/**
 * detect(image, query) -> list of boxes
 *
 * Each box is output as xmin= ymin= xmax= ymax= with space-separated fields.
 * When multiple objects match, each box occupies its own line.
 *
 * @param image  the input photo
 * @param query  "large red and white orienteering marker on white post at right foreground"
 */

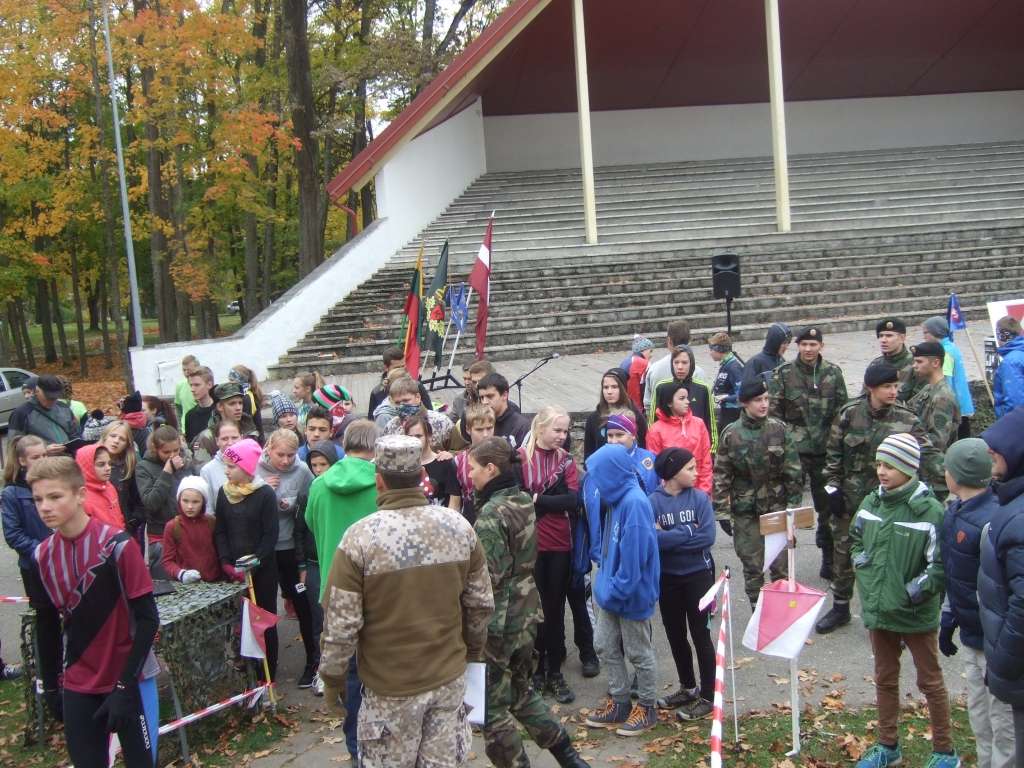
xmin=743 ymin=579 xmax=825 ymax=658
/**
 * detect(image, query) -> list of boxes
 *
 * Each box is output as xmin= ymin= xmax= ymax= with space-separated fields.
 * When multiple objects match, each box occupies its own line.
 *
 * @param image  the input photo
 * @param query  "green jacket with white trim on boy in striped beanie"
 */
xmin=850 ymin=477 xmax=945 ymax=633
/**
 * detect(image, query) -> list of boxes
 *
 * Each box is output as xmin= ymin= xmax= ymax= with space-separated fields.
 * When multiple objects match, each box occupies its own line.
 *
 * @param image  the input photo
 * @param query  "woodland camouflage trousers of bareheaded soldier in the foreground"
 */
xmin=483 ymin=642 xmax=563 ymax=768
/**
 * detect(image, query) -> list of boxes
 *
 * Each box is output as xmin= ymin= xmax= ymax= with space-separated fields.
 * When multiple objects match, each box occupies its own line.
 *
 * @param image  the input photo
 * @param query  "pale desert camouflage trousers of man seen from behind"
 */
xmin=358 ymin=675 xmax=473 ymax=768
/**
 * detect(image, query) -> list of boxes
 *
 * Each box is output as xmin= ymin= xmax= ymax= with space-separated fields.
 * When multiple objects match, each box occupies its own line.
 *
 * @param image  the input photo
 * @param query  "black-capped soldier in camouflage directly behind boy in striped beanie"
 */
xmin=817 ymin=360 xmax=943 ymax=634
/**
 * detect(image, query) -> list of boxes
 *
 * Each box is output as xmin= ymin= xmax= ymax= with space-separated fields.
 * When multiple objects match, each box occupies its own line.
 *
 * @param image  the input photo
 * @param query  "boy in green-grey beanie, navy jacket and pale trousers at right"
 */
xmin=939 ymin=437 xmax=1014 ymax=768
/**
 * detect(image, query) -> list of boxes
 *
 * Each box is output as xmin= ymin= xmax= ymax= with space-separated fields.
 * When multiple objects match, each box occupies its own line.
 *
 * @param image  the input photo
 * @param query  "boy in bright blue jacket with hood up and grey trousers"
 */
xmin=586 ymin=444 xmax=660 ymax=736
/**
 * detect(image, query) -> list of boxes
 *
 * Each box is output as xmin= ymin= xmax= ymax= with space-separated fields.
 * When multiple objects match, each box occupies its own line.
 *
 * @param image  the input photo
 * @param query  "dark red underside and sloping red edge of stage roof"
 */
xmin=330 ymin=0 xmax=1024 ymax=195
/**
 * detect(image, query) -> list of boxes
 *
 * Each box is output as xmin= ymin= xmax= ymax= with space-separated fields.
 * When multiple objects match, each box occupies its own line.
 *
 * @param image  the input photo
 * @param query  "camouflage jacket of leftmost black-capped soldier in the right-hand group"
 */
xmin=712 ymin=411 xmax=804 ymax=519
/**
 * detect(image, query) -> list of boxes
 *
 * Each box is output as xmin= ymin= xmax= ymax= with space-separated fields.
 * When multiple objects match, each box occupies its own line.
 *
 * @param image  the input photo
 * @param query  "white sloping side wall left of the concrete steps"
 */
xmin=131 ymin=101 xmax=486 ymax=394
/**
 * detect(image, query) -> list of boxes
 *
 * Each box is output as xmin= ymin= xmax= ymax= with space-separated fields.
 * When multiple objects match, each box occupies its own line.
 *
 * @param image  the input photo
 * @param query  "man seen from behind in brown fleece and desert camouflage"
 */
xmin=319 ymin=435 xmax=495 ymax=768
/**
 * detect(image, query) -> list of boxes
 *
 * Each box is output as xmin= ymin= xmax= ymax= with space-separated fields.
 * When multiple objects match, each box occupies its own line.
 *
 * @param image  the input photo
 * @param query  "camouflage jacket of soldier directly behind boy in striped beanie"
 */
xmin=825 ymin=394 xmax=942 ymax=514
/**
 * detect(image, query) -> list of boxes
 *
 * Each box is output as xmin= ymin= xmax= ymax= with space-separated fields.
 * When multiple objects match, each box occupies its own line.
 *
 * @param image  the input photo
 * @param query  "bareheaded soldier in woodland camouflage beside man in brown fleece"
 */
xmin=469 ymin=437 xmax=588 ymax=768
